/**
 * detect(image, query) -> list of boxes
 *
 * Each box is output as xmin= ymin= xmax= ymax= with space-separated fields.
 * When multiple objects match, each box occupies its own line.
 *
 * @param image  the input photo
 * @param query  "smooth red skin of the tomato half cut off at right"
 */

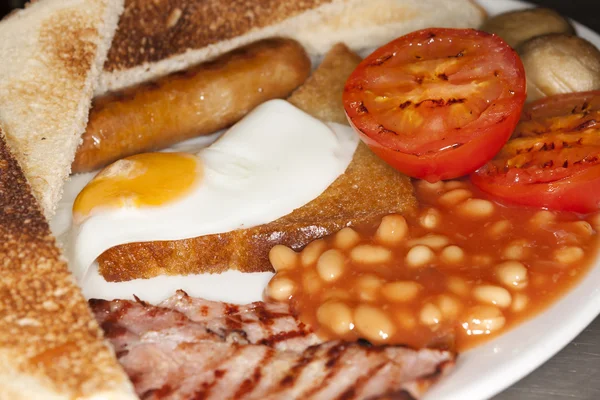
xmin=471 ymin=165 xmax=600 ymax=214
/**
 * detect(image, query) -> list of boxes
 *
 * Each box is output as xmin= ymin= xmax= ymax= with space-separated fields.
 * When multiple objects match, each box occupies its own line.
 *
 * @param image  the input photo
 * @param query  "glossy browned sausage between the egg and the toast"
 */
xmin=72 ymin=38 xmax=310 ymax=173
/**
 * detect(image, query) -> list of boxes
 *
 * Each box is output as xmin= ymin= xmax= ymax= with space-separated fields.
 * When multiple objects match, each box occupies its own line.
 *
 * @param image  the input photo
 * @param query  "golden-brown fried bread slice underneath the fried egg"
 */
xmin=98 ymin=45 xmax=416 ymax=281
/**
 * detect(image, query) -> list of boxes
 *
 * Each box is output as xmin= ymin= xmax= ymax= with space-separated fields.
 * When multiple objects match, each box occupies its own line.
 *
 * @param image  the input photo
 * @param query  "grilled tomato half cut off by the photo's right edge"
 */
xmin=471 ymin=91 xmax=600 ymax=213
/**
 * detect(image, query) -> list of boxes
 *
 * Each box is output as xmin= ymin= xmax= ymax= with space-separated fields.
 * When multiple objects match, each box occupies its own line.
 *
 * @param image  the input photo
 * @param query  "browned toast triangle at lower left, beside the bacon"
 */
xmin=0 ymin=130 xmax=136 ymax=400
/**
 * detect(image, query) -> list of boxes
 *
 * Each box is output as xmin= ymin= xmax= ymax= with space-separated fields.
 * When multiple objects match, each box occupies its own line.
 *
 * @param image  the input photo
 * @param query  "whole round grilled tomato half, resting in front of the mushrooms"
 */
xmin=343 ymin=28 xmax=526 ymax=182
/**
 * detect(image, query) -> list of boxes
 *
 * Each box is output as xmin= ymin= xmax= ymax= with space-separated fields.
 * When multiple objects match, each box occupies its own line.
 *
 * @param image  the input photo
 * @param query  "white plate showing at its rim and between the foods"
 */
xmin=51 ymin=0 xmax=600 ymax=400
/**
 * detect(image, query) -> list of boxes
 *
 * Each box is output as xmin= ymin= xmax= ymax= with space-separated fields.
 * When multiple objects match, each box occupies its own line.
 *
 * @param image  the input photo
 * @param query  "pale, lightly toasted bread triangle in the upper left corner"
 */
xmin=0 ymin=0 xmax=123 ymax=218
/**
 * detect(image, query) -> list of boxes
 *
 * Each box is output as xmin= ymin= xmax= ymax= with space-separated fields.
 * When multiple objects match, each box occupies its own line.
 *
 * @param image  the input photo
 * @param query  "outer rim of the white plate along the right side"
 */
xmin=425 ymin=0 xmax=600 ymax=400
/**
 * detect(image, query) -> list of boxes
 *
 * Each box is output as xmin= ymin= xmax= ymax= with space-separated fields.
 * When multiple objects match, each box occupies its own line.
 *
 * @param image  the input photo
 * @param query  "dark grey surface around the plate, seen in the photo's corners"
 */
xmin=0 ymin=0 xmax=600 ymax=400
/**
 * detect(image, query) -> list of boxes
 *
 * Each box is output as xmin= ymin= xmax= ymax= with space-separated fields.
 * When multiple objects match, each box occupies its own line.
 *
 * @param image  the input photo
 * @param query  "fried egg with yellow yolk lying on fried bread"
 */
xmin=65 ymin=100 xmax=359 ymax=281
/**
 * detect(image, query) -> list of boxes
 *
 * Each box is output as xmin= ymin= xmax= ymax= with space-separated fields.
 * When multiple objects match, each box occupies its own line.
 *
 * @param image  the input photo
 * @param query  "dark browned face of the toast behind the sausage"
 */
xmin=104 ymin=0 xmax=332 ymax=72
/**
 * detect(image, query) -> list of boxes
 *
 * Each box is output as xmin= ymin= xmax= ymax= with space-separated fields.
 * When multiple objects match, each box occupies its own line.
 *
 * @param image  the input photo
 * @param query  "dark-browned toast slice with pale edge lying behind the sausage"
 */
xmin=97 ymin=0 xmax=485 ymax=94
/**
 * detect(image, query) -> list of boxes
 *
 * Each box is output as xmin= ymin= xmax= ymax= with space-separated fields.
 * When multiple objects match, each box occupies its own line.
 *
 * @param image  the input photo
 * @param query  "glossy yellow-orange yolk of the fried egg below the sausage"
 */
xmin=73 ymin=153 xmax=202 ymax=223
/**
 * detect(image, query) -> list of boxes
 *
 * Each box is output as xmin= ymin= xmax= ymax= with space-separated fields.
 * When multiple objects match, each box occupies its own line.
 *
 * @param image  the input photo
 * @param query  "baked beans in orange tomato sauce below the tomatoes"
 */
xmin=266 ymin=181 xmax=600 ymax=351
